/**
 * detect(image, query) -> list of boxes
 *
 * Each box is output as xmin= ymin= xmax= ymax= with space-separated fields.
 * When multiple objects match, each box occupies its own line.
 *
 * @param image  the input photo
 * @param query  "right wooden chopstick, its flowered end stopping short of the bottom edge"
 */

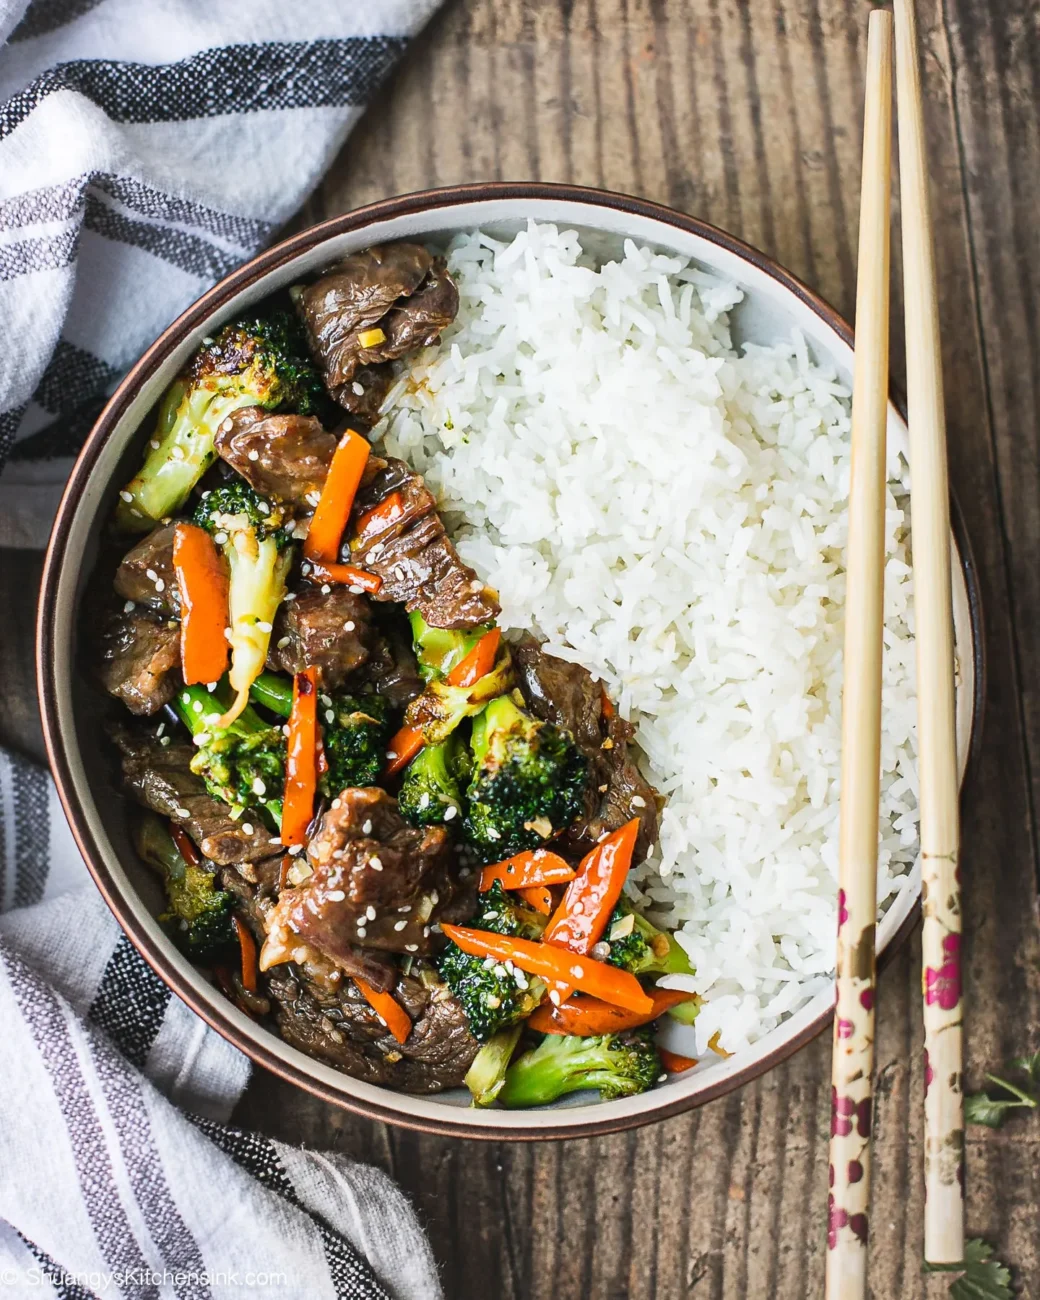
xmin=896 ymin=0 xmax=965 ymax=1264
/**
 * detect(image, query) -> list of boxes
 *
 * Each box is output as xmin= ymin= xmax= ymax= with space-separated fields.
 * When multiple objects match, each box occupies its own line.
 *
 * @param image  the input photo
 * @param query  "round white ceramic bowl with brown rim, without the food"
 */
xmin=38 ymin=183 xmax=982 ymax=1139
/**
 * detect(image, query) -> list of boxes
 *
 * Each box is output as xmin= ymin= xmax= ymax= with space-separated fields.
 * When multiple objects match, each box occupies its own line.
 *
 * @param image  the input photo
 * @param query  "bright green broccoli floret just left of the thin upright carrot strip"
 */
xmin=170 ymin=683 xmax=286 ymax=822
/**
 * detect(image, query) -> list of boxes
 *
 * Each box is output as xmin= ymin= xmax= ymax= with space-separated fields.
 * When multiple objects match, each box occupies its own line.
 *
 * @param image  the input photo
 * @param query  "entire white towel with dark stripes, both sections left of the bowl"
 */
xmin=0 ymin=0 xmax=441 ymax=1300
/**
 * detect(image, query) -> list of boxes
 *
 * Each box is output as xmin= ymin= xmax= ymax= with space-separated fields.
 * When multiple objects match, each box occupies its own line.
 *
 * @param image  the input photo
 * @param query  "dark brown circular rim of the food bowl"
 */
xmin=36 ymin=181 xmax=985 ymax=1141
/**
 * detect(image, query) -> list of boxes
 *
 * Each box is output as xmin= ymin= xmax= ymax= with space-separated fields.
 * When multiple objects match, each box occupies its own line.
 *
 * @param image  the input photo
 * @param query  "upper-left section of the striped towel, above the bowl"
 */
xmin=0 ymin=0 xmax=439 ymax=546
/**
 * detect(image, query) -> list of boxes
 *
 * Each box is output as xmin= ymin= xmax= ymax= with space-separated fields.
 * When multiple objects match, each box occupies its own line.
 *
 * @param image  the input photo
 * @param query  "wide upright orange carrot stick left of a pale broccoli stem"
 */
xmin=173 ymin=524 xmax=228 ymax=686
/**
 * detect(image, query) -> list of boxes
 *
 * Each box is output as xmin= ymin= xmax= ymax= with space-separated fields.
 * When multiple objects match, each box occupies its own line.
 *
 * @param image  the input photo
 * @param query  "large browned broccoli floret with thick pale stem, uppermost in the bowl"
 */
xmin=116 ymin=312 xmax=328 ymax=532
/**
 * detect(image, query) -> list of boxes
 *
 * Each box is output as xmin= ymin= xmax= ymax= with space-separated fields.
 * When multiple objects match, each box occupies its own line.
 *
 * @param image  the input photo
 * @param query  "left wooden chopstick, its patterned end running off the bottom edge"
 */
xmin=827 ymin=9 xmax=892 ymax=1300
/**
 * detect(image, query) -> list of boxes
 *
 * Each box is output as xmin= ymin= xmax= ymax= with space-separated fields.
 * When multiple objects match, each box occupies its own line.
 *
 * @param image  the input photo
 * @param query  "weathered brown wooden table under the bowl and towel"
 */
xmin=0 ymin=0 xmax=1040 ymax=1300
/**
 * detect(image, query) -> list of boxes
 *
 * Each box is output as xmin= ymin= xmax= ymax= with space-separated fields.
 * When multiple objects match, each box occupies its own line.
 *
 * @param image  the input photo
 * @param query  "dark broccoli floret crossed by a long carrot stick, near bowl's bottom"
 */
xmin=437 ymin=881 xmax=545 ymax=1043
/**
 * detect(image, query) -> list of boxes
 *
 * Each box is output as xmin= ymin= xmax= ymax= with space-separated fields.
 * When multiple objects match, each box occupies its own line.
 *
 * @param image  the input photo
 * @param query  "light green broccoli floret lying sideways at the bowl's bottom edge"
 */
xmin=498 ymin=1027 xmax=660 ymax=1108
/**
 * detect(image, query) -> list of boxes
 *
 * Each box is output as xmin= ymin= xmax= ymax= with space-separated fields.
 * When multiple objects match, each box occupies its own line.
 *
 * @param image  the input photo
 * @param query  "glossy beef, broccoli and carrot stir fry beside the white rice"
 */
xmin=90 ymin=243 xmax=698 ymax=1106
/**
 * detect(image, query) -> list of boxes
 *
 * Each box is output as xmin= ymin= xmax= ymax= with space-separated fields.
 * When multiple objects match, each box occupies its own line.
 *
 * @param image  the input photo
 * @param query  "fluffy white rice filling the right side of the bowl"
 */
xmin=385 ymin=224 xmax=918 ymax=1050
